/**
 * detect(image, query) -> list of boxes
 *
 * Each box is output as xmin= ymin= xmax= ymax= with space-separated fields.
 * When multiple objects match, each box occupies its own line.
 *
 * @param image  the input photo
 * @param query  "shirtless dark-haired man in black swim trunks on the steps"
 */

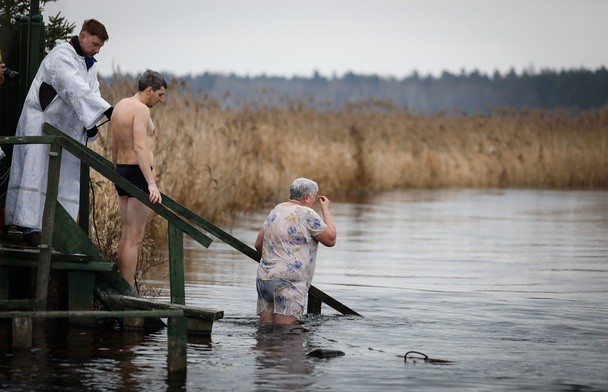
xmin=111 ymin=70 xmax=167 ymax=287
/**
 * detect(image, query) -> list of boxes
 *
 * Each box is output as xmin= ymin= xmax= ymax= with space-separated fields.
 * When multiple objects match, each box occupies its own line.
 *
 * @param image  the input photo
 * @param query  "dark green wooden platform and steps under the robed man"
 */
xmin=0 ymin=227 xmax=224 ymax=335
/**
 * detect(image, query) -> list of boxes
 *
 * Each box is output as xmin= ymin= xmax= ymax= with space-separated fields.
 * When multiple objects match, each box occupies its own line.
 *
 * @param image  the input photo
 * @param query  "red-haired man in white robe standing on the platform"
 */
xmin=5 ymin=19 xmax=113 ymax=246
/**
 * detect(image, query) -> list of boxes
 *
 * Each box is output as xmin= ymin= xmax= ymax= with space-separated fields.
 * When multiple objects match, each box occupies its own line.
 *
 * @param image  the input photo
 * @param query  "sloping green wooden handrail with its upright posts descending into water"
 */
xmin=0 ymin=124 xmax=360 ymax=316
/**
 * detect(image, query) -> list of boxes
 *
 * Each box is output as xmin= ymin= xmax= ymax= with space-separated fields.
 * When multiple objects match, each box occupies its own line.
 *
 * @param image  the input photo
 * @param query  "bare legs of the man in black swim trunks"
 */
xmin=118 ymin=196 xmax=150 ymax=287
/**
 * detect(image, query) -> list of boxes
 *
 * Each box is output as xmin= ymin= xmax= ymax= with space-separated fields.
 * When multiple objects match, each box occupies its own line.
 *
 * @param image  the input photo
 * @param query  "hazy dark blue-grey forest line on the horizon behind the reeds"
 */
xmin=163 ymin=67 xmax=608 ymax=114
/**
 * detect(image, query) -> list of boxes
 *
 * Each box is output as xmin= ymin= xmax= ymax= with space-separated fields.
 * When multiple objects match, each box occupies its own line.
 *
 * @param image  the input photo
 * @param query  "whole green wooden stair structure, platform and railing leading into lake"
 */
xmin=0 ymin=124 xmax=359 ymax=373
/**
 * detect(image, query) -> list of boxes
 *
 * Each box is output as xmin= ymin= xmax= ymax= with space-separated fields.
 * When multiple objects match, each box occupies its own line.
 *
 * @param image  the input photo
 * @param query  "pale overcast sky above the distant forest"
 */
xmin=44 ymin=0 xmax=608 ymax=78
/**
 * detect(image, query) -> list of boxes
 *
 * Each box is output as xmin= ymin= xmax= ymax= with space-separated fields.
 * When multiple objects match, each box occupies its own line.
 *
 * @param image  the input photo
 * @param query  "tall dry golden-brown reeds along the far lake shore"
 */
xmin=92 ymin=80 xmax=608 ymax=276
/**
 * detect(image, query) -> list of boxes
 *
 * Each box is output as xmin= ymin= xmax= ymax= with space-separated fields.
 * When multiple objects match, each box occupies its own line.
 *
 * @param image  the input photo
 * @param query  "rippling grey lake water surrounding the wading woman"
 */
xmin=0 ymin=189 xmax=608 ymax=391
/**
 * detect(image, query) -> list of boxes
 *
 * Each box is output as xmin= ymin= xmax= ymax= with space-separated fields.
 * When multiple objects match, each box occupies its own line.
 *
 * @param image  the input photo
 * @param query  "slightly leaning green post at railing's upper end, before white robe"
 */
xmin=35 ymin=142 xmax=61 ymax=310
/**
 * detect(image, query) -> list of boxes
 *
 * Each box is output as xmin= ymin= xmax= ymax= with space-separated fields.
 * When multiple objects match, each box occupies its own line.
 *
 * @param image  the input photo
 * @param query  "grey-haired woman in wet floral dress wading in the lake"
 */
xmin=255 ymin=178 xmax=336 ymax=324
